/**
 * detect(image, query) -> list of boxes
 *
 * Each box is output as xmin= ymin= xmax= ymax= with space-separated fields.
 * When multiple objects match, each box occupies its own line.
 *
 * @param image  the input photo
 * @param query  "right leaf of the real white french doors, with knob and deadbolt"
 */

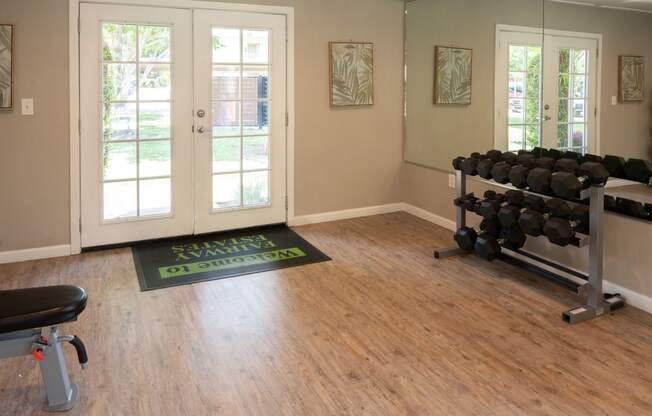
xmin=194 ymin=10 xmax=286 ymax=233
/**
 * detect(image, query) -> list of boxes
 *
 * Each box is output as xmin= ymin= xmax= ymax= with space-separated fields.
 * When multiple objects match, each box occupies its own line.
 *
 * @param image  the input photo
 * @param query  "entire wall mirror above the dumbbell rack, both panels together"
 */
xmin=404 ymin=0 xmax=652 ymax=171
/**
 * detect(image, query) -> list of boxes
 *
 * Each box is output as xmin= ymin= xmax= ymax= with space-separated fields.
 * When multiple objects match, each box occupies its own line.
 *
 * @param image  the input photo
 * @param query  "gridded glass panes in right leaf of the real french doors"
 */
xmin=211 ymin=28 xmax=272 ymax=211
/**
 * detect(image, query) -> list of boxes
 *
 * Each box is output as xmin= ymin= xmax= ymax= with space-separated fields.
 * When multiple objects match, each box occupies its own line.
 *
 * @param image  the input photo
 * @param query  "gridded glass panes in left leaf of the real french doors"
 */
xmin=101 ymin=22 xmax=173 ymax=221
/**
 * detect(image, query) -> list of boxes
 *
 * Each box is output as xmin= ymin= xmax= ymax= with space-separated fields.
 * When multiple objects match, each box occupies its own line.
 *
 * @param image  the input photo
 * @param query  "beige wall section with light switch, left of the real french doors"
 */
xmin=0 ymin=0 xmax=70 ymax=252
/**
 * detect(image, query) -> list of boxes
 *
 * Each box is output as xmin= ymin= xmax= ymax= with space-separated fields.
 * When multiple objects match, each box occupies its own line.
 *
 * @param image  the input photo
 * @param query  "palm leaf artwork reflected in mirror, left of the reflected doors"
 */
xmin=434 ymin=46 xmax=472 ymax=105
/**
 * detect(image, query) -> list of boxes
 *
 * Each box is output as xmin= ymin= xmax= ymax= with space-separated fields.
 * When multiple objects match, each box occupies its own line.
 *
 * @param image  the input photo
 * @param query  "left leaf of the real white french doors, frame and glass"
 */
xmin=80 ymin=4 xmax=193 ymax=247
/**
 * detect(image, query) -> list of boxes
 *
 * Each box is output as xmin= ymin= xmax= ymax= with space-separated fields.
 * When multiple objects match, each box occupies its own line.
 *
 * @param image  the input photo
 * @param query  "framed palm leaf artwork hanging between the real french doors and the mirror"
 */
xmin=330 ymin=42 xmax=374 ymax=106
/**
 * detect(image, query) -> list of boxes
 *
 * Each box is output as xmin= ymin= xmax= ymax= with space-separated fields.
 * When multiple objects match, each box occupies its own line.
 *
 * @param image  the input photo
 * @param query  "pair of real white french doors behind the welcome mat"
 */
xmin=80 ymin=3 xmax=286 ymax=247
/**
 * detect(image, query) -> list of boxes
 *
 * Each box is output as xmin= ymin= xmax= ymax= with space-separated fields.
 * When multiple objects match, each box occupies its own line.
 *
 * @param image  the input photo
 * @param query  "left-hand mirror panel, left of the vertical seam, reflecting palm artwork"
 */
xmin=404 ymin=0 xmax=544 ymax=171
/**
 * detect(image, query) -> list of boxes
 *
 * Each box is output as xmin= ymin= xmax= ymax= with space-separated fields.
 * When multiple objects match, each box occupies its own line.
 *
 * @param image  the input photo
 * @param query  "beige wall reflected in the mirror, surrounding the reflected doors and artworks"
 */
xmin=405 ymin=0 xmax=652 ymax=170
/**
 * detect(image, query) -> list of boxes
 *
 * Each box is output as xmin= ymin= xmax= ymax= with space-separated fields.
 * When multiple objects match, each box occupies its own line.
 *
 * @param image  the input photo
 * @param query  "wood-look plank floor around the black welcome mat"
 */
xmin=0 ymin=213 xmax=652 ymax=416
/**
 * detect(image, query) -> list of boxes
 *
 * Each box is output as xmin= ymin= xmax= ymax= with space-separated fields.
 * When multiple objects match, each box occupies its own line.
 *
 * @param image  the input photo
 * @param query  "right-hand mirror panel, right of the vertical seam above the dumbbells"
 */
xmin=542 ymin=0 xmax=652 ymax=159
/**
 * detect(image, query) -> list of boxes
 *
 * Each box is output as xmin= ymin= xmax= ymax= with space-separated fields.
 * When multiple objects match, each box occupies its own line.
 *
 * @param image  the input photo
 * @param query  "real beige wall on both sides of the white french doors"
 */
xmin=0 ymin=0 xmax=403 ymax=251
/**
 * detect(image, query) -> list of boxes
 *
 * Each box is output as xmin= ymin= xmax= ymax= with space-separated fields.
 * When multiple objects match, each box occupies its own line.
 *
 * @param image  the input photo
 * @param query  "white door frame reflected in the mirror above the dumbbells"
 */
xmin=494 ymin=24 xmax=602 ymax=155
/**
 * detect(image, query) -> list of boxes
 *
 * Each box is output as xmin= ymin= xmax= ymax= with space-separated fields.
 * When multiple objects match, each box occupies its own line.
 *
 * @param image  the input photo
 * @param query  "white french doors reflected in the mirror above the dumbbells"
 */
xmin=494 ymin=26 xmax=598 ymax=153
